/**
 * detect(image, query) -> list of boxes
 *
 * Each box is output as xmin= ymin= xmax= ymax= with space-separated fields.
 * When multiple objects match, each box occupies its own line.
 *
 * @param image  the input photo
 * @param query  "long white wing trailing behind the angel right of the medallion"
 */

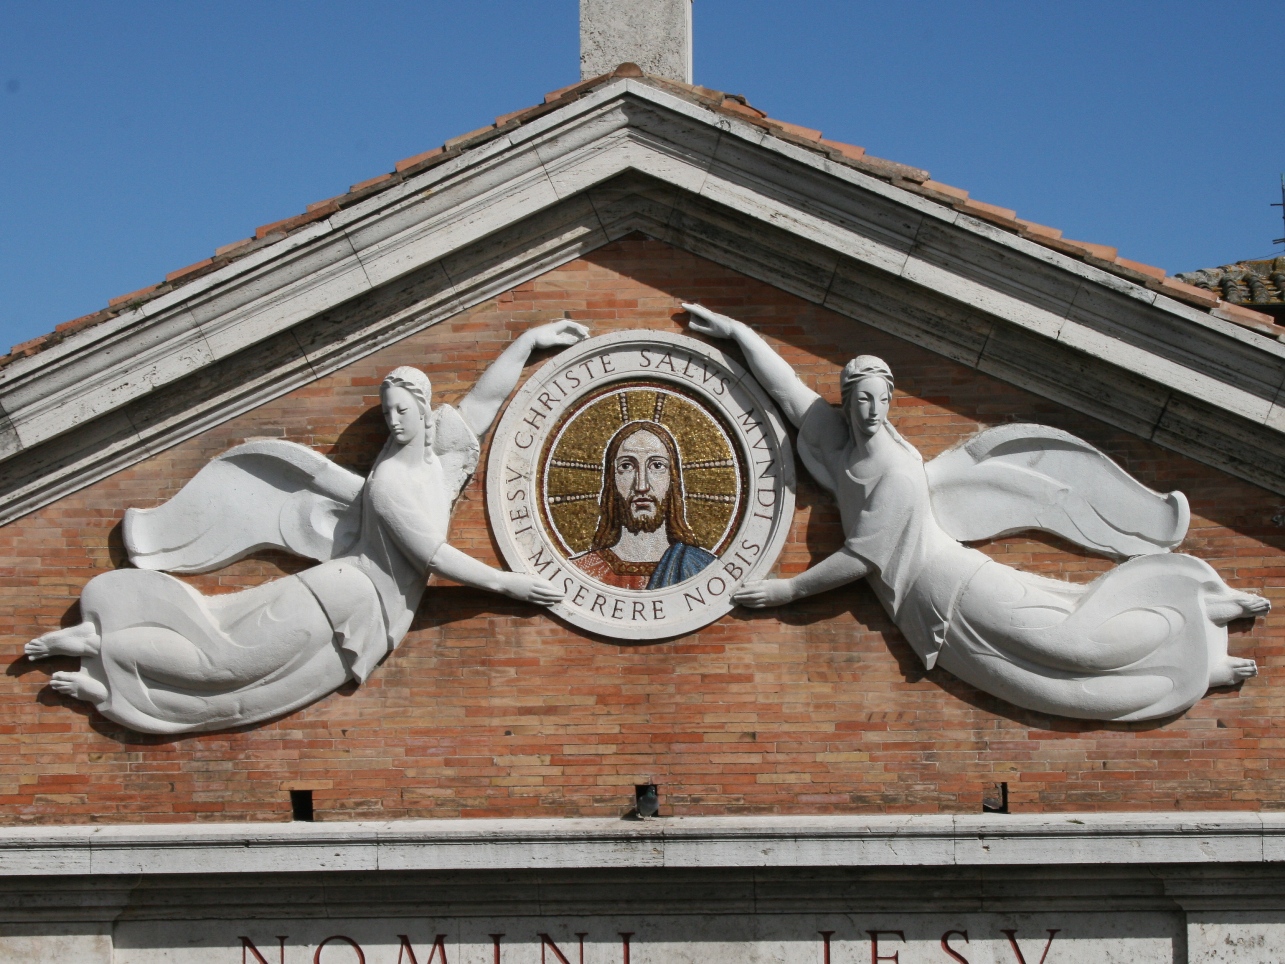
xmin=926 ymin=424 xmax=1191 ymax=558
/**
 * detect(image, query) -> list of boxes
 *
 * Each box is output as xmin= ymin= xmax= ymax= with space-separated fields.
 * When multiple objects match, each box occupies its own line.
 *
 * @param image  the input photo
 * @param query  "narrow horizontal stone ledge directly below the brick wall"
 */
xmin=0 ymin=811 xmax=1285 ymax=877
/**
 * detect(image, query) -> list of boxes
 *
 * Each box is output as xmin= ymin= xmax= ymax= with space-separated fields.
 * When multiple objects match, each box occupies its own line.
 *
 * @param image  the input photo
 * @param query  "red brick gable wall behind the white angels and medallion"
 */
xmin=0 ymin=240 xmax=1285 ymax=824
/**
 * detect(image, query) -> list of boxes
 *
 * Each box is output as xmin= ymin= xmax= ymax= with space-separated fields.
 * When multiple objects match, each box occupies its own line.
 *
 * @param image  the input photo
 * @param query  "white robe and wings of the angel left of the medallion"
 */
xmin=72 ymin=405 xmax=479 ymax=734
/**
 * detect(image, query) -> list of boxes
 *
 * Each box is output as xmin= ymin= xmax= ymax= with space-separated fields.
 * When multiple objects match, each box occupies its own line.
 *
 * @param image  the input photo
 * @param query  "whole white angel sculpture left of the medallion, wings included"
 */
xmin=26 ymin=321 xmax=589 ymax=734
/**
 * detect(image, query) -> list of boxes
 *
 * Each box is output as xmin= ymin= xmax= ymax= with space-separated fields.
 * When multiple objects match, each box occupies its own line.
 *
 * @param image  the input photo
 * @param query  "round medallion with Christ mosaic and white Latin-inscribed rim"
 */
xmin=487 ymin=332 xmax=794 ymax=640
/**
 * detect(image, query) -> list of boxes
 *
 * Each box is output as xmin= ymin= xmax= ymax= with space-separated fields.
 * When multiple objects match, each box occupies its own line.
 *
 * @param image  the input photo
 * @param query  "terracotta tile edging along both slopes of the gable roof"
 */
xmin=0 ymin=63 xmax=1285 ymax=368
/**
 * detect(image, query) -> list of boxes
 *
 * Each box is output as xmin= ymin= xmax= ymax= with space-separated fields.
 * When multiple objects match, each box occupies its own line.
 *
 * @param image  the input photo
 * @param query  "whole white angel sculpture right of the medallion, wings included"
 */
xmin=684 ymin=305 xmax=1270 ymax=720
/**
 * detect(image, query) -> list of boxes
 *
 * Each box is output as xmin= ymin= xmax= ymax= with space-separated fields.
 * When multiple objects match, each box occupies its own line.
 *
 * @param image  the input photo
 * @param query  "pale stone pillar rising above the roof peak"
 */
xmin=580 ymin=0 xmax=693 ymax=84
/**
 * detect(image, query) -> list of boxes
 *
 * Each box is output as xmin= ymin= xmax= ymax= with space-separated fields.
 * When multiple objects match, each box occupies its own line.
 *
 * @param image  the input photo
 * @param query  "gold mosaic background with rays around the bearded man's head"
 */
xmin=541 ymin=382 xmax=745 ymax=554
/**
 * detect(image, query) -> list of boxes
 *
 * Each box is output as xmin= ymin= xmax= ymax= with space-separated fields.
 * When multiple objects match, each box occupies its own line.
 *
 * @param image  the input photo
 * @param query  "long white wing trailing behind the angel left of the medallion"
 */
xmin=125 ymin=440 xmax=362 ymax=572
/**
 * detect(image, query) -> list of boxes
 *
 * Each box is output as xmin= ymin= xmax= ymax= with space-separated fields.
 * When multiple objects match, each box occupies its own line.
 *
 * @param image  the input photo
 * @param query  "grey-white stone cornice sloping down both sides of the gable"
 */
xmin=0 ymin=78 xmax=1285 ymax=523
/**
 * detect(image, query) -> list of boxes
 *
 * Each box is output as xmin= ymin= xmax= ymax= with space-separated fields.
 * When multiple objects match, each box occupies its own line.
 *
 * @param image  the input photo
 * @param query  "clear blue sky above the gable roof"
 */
xmin=0 ymin=0 xmax=1285 ymax=351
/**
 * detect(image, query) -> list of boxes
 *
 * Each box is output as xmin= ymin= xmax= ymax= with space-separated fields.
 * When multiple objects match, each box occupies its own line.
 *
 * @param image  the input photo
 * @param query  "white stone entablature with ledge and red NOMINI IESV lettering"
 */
xmin=0 ymin=812 xmax=1285 ymax=964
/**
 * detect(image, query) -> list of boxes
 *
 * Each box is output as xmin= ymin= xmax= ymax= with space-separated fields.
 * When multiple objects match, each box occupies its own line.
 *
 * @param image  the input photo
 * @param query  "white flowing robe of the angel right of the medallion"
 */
xmin=798 ymin=405 xmax=1226 ymax=720
